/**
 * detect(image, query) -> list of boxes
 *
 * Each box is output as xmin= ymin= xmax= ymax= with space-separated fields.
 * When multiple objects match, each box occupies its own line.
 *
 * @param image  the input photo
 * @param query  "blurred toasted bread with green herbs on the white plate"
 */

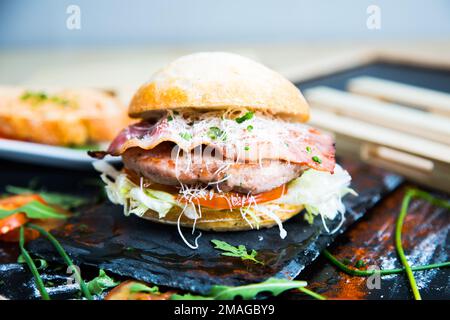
xmin=0 ymin=86 xmax=130 ymax=146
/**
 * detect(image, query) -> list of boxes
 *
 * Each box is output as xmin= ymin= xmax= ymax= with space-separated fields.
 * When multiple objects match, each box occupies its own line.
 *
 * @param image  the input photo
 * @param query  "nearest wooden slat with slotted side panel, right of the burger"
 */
xmin=310 ymin=104 xmax=450 ymax=192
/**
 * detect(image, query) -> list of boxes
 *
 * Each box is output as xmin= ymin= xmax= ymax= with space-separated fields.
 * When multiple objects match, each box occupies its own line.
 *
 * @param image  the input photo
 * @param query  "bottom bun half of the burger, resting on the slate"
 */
xmin=142 ymin=204 xmax=303 ymax=231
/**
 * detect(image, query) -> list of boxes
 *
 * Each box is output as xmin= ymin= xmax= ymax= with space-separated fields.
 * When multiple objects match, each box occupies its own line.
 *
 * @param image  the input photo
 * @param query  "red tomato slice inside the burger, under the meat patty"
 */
xmin=178 ymin=184 xmax=286 ymax=210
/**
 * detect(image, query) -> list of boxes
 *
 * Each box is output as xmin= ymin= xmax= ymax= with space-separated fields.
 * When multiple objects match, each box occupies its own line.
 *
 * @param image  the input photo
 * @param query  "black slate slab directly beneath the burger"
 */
xmin=29 ymin=162 xmax=402 ymax=293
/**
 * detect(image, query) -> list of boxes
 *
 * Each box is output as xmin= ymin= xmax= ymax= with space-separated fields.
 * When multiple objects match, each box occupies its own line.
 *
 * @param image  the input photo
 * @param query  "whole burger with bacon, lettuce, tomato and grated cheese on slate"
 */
xmin=90 ymin=52 xmax=352 ymax=248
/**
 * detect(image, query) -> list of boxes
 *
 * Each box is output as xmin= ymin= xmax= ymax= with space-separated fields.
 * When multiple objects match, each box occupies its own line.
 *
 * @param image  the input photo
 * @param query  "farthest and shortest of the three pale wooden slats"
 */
xmin=348 ymin=77 xmax=450 ymax=117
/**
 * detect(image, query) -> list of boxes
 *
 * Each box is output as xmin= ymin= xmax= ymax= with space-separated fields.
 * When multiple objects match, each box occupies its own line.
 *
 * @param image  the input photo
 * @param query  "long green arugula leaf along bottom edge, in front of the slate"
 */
xmin=170 ymin=278 xmax=307 ymax=300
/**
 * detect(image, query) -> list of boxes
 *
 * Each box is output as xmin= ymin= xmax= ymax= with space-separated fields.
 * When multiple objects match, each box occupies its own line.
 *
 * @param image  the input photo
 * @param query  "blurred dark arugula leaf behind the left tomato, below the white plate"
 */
xmin=5 ymin=186 xmax=89 ymax=210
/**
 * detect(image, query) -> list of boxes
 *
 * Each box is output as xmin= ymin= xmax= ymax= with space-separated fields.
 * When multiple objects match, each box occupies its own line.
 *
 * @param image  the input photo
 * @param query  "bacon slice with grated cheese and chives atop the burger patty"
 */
xmin=90 ymin=116 xmax=335 ymax=172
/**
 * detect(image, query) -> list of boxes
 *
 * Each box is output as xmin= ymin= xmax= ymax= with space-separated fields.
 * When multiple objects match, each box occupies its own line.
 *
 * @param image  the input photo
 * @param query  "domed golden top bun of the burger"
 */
xmin=128 ymin=52 xmax=309 ymax=122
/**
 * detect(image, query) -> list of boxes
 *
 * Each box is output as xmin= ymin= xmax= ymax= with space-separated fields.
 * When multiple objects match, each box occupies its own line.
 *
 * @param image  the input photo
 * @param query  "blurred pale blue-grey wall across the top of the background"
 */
xmin=0 ymin=0 xmax=450 ymax=48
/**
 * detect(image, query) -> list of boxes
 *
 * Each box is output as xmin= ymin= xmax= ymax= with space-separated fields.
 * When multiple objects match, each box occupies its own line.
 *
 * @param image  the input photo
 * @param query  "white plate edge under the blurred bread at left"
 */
xmin=0 ymin=139 xmax=120 ymax=169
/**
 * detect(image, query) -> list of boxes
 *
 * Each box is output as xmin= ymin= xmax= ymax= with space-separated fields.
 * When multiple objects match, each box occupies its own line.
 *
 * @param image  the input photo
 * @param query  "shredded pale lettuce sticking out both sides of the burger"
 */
xmin=94 ymin=161 xmax=356 ymax=234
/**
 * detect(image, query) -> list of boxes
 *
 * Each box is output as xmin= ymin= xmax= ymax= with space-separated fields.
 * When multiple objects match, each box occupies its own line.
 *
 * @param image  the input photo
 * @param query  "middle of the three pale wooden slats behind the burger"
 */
xmin=305 ymin=87 xmax=450 ymax=145
